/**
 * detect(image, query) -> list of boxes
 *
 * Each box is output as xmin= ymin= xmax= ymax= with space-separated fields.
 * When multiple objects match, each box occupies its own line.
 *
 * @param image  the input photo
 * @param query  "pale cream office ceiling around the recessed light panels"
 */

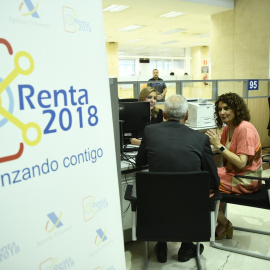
xmin=102 ymin=0 xmax=234 ymax=58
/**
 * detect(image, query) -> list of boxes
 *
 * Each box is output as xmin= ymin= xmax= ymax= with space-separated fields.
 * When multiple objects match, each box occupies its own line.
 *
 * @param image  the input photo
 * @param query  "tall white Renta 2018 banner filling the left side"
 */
xmin=0 ymin=0 xmax=125 ymax=270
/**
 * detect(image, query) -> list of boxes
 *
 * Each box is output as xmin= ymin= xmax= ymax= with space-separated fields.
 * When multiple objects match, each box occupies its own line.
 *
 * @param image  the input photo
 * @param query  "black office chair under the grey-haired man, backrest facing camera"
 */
xmin=125 ymin=171 xmax=221 ymax=269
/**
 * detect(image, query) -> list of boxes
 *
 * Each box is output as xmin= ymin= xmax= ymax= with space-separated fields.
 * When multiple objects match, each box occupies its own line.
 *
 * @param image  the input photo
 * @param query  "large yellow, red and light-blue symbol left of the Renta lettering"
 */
xmin=0 ymin=39 xmax=42 ymax=163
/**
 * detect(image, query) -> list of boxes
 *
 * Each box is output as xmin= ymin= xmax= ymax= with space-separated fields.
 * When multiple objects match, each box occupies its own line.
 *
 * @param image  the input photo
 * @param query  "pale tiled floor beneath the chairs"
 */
xmin=125 ymin=165 xmax=270 ymax=270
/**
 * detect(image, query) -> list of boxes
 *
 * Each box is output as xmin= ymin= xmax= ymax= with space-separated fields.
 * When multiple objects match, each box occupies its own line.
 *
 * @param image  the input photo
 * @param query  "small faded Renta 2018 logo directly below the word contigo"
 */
xmin=82 ymin=196 xmax=109 ymax=222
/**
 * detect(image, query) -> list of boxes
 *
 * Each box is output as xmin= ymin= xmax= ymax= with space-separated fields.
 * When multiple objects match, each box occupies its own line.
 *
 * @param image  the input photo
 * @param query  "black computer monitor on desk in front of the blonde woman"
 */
xmin=118 ymin=102 xmax=150 ymax=142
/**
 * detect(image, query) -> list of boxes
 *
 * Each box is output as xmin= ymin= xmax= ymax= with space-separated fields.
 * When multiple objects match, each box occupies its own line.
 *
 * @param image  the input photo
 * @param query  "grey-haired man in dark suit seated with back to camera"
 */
xmin=136 ymin=95 xmax=220 ymax=263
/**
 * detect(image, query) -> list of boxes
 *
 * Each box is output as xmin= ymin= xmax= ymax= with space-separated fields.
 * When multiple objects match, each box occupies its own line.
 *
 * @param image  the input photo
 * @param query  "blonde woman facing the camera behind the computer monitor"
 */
xmin=130 ymin=86 xmax=163 ymax=145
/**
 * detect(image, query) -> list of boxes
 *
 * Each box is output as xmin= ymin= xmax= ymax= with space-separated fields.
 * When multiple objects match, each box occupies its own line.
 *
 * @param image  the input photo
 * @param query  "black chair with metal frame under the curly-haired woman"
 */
xmin=211 ymin=175 xmax=270 ymax=260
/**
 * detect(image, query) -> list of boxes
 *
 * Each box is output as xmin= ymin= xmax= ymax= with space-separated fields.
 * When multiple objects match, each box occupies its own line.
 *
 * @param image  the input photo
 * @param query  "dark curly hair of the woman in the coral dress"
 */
xmin=215 ymin=93 xmax=250 ymax=128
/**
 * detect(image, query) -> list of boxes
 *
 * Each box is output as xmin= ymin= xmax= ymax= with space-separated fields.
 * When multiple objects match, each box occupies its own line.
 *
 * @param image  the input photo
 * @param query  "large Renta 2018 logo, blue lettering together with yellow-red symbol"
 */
xmin=0 ymin=38 xmax=99 ymax=167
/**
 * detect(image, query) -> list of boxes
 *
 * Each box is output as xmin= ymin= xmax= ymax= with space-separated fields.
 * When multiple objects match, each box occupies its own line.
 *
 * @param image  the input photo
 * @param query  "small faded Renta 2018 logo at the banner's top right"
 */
xmin=63 ymin=7 xmax=92 ymax=33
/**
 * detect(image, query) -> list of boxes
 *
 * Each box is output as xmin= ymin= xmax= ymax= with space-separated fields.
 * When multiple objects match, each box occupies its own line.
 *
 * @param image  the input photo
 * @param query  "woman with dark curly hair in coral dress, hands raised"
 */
xmin=206 ymin=93 xmax=262 ymax=240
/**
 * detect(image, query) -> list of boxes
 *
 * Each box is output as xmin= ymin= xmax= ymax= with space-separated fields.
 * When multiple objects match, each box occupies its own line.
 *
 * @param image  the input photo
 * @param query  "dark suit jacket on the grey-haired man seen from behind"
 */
xmin=137 ymin=121 xmax=219 ymax=189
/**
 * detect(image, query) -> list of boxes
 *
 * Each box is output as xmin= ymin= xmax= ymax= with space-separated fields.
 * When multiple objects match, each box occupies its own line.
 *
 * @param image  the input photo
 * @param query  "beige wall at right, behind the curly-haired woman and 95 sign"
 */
xmin=211 ymin=0 xmax=270 ymax=146
